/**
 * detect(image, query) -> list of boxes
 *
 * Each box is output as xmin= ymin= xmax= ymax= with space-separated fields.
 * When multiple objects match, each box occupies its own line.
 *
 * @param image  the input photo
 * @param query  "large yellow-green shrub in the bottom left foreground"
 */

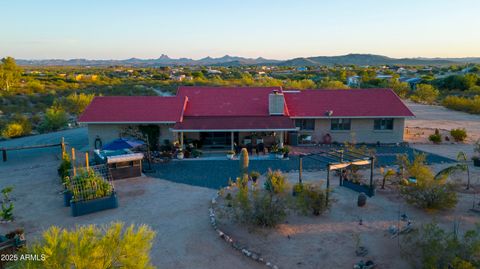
xmin=15 ymin=222 xmax=155 ymax=269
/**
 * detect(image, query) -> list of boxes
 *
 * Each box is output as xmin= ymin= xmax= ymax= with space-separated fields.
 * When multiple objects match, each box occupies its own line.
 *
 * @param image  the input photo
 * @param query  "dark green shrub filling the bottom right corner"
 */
xmin=402 ymin=223 xmax=480 ymax=269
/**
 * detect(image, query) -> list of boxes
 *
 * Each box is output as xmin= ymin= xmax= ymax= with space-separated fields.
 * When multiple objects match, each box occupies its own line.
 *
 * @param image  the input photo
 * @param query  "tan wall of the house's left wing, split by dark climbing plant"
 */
xmin=88 ymin=124 xmax=173 ymax=150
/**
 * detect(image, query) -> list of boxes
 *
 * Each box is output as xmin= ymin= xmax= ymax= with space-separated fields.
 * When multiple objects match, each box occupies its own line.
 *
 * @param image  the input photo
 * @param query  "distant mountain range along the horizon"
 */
xmin=17 ymin=54 xmax=480 ymax=67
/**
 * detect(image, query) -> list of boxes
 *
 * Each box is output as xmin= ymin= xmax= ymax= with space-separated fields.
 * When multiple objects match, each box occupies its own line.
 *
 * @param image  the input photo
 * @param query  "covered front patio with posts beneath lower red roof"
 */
xmin=172 ymin=116 xmax=297 ymax=153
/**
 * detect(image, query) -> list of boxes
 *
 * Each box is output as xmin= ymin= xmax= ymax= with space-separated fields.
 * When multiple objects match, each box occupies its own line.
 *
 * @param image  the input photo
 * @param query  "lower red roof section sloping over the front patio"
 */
xmin=173 ymin=116 xmax=295 ymax=131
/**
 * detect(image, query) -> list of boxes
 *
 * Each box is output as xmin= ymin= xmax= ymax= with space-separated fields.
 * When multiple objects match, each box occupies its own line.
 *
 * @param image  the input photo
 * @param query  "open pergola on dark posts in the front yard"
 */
xmin=298 ymin=149 xmax=375 ymax=203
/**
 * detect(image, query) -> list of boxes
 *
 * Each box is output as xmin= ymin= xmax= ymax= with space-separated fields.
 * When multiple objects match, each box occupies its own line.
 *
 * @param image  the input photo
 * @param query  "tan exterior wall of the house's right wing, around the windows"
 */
xmin=299 ymin=118 xmax=405 ymax=143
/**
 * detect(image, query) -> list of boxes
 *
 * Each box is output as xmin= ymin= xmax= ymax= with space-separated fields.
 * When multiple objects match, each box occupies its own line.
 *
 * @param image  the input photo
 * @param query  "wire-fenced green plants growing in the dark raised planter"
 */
xmin=66 ymin=165 xmax=115 ymax=202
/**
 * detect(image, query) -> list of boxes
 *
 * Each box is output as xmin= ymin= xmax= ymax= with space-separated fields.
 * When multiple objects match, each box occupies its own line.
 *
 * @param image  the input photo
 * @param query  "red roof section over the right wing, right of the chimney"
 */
xmin=284 ymin=89 xmax=414 ymax=117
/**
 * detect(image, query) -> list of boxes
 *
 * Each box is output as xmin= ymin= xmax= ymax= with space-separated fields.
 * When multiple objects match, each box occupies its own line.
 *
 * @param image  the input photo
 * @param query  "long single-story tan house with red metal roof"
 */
xmin=79 ymin=86 xmax=414 ymax=149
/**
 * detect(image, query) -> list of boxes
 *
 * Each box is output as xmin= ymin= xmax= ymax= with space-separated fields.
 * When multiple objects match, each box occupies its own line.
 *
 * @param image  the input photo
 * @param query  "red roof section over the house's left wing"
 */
xmin=79 ymin=96 xmax=185 ymax=123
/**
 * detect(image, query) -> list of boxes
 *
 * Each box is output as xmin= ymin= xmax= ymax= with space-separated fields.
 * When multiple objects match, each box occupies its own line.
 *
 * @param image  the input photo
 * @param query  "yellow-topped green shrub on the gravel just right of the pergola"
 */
xmin=400 ymin=154 xmax=458 ymax=209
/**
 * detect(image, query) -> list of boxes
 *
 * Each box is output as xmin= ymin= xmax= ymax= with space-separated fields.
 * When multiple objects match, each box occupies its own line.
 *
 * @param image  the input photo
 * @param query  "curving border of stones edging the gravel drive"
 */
xmin=208 ymin=192 xmax=278 ymax=269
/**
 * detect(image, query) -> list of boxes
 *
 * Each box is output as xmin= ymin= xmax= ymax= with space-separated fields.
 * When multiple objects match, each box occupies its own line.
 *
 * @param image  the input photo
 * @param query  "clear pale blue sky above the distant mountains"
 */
xmin=0 ymin=0 xmax=480 ymax=59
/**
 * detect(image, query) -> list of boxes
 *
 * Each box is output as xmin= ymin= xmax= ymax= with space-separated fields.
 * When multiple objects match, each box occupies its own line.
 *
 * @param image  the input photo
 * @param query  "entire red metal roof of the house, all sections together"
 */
xmin=79 ymin=87 xmax=414 ymax=126
